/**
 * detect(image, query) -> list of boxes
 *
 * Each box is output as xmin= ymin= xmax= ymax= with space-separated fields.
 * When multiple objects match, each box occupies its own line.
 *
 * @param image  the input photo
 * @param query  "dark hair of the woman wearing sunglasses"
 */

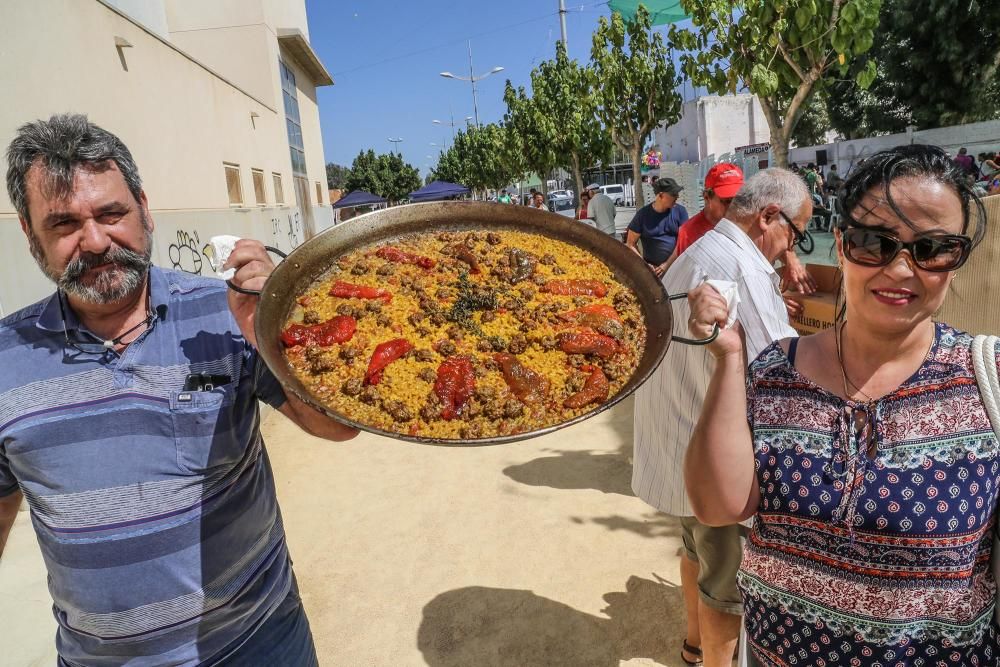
xmin=839 ymin=144 xmax=986 ymax=247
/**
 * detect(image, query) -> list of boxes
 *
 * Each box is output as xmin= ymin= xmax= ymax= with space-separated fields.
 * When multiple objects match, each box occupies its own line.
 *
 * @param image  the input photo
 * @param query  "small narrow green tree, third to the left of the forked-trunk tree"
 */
xmin=503 ymin=79 xmax=559 ymax=193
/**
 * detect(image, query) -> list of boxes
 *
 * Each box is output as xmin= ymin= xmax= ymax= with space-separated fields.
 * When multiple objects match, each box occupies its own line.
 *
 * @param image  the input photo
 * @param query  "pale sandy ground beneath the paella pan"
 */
xmin=0 ymin=400 xmax=696 ymax=667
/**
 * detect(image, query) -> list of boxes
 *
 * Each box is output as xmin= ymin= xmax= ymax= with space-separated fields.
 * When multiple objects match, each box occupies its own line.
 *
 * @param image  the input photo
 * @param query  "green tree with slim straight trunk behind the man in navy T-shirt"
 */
xmin=590 ymin=5 xmax=684 ymax=207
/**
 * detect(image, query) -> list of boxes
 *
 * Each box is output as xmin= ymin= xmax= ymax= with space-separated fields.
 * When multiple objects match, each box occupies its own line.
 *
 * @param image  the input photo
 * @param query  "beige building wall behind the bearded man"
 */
xmin=0 ymin=0 xmax=333 ymax=315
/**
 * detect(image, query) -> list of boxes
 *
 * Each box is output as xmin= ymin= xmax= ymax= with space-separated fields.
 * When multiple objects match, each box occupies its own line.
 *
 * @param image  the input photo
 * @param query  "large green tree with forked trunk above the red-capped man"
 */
xmin=670 ymin=0 xmax=882 ymax=167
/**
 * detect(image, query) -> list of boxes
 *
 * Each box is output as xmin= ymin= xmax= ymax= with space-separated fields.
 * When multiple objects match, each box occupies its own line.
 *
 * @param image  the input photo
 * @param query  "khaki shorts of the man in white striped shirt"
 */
xmin=681 ymin=516 xmax=746 ymax=616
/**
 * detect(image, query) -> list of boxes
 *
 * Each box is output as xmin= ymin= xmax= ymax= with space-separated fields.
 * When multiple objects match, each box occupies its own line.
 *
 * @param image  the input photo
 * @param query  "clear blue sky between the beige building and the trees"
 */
xmin=306 ymin=0 xmax=636 ymax=174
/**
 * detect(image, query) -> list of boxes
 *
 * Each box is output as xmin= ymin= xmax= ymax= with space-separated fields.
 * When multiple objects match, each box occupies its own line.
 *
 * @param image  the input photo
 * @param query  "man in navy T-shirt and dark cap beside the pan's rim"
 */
xmin=625 ymin=178 xmax=688 ymax=278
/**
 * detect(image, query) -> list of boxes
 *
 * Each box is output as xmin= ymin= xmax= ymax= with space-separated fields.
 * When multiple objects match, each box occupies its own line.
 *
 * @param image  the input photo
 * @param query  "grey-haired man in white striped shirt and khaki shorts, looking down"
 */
xmin=632 ymin=169 xmax=812 ymax=667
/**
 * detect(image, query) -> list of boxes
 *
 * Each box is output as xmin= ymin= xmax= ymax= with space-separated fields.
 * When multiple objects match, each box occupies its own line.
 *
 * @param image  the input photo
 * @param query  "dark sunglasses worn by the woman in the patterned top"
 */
xmin=840 ymin=225 xmax=972 ymax=273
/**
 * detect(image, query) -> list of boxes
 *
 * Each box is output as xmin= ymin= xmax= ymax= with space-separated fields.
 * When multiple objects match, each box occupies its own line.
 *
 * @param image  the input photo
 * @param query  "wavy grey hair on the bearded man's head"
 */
xmin=7 ymin=114 xmax=142 ymax=222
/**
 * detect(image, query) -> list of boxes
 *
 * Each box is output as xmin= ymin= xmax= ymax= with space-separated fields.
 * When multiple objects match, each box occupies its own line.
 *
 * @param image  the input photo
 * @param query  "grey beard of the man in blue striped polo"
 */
xmin=28 ymin=216 xmax=153 ymax=304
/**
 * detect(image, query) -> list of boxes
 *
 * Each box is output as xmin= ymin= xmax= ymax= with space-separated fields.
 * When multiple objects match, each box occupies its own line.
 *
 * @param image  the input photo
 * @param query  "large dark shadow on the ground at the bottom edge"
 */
xmin=417 ymin=575 xmax=684 ymax=667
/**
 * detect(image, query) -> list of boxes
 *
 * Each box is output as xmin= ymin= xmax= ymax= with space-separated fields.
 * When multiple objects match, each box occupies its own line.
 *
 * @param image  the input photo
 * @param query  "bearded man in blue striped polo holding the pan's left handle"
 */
xmin=0 ymin=115 xmax=356 ymax=667
